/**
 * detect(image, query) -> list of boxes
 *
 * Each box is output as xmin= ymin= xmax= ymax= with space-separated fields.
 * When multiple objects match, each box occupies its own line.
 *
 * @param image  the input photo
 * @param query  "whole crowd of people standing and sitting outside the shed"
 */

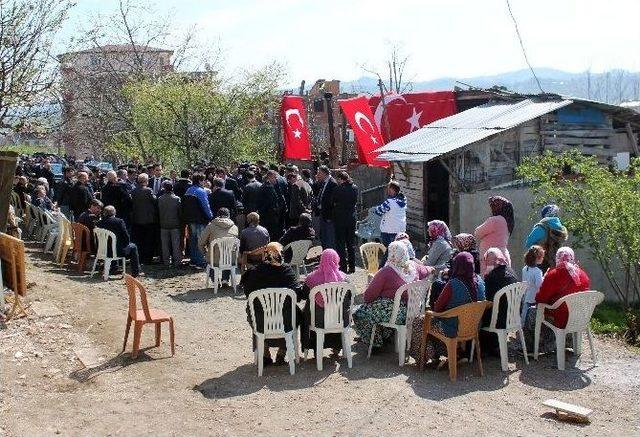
xmin=14 ymin=153 xmax=590 ymax=364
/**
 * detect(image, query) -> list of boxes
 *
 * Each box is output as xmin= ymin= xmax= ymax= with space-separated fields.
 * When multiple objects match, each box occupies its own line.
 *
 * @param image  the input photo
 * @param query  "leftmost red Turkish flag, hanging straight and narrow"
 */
xmin=280 ymin=96 xmax=311 ymax=160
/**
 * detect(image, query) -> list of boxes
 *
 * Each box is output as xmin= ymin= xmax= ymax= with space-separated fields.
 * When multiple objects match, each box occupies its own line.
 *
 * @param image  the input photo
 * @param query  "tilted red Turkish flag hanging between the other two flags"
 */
xmin=338 ymin=97 xmax=389 ymax=167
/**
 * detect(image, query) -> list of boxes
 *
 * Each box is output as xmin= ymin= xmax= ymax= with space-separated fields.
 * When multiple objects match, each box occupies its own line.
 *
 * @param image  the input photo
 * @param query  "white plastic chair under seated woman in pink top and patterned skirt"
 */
xmin=367 ymin=279 xmax=431 ymax=366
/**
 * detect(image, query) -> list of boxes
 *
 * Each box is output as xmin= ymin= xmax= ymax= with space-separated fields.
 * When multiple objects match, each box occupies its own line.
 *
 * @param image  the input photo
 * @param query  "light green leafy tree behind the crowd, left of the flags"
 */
xmin=111 ymin=64 xmax=282 ymax=167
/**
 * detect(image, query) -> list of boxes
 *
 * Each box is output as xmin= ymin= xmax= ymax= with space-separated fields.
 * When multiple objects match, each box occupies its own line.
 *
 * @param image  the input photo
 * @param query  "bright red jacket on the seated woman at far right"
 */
xmin=536 ymin=267 xmax=591 ymax=328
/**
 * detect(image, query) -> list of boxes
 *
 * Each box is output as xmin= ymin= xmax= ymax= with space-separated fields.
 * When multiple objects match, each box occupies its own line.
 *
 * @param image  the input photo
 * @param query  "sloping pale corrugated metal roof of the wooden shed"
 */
xmin=377 ymin=99 xmax=573 ymax=162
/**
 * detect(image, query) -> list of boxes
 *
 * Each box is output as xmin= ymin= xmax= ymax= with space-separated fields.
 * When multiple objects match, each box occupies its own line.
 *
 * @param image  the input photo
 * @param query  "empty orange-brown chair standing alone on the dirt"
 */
xmin=122 ymin=274 xmax=176 ymax=359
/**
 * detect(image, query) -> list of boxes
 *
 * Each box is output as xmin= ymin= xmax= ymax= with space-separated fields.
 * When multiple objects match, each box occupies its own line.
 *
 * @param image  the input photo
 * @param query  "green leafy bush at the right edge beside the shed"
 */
xmin=518 ymin=152 xmax=640 ymax=308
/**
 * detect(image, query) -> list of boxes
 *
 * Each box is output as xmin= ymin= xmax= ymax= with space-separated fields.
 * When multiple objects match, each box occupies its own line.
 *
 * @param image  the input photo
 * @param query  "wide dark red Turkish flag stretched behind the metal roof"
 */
xmin=369 ymin=91 xmax=457 ymax=142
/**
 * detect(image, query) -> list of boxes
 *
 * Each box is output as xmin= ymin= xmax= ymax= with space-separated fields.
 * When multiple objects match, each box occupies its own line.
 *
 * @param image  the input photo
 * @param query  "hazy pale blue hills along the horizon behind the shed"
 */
xmin=340 ymin=68 xmax=640 ymax=104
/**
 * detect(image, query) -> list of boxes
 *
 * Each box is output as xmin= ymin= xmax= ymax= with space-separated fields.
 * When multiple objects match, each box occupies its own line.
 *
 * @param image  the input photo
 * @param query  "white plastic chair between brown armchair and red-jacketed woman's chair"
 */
xmin=478 ymin=282 xmax=529 ymax=372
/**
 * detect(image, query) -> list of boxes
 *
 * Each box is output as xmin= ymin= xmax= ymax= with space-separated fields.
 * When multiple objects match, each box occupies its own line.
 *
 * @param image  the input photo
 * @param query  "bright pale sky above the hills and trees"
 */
xmin=65 ymin=0 xmax=640 ymax=84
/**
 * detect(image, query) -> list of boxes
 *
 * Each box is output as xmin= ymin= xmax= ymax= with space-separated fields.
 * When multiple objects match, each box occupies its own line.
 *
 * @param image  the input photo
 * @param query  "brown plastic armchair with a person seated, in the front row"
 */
xmin=418 ymin=301 xmax=491 ymax=381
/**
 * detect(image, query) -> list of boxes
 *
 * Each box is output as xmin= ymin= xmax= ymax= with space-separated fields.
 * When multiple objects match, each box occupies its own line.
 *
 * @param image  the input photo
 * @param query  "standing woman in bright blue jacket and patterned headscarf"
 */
xmin=524 ymin=204 xmax=569 ymax=272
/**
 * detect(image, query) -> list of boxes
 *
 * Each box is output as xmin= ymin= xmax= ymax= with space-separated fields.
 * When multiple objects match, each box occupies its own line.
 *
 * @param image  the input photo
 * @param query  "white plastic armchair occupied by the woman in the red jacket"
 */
xmin=533 ymin=290 xmax=604 ymax=370
